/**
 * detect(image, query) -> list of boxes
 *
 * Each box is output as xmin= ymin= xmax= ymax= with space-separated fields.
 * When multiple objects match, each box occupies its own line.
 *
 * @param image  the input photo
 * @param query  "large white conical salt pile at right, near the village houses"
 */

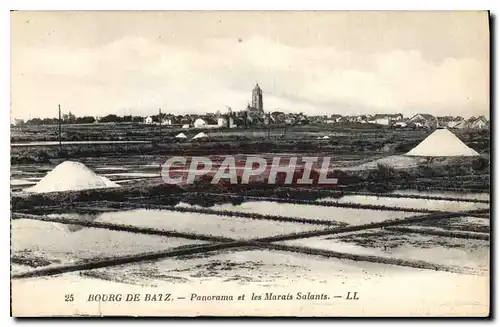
xmin=406 ymin=129 xmax=479 ymax=157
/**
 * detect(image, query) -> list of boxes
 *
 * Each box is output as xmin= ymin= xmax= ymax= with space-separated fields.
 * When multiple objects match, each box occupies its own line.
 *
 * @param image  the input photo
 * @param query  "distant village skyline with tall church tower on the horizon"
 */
xmin=13 ymin=84 xmax=490 ymax=129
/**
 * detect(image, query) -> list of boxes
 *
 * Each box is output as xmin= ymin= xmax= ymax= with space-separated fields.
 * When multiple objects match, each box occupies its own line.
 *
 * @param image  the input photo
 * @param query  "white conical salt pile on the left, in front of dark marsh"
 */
xmin=26 ymin=161 xmax=120 ymax=193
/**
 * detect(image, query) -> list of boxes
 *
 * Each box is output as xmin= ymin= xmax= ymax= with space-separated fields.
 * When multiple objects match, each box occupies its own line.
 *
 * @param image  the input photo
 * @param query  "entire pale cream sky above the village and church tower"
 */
xmin=11 ymin=11 xmax=489 ymax=119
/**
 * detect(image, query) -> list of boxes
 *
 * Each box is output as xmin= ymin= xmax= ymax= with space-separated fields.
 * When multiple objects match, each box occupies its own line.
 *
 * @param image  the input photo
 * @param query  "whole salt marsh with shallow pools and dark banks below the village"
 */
xmin=11 ymin=125 xmax=490 ymax=316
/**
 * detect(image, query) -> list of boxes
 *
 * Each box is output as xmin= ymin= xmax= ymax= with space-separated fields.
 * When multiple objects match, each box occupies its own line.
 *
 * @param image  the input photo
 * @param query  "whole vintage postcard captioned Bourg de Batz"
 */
xmin=10 ymin=11 xmax=491 ymax=317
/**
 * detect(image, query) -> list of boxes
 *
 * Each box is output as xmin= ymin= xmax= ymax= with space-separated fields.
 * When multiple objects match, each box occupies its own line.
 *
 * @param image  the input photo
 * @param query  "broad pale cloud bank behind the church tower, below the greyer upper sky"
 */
xmin=11 ymin=35 xmax=489 ymax=118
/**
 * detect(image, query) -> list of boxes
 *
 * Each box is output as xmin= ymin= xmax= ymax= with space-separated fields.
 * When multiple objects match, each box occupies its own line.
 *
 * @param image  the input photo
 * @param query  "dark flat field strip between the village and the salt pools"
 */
xmin=11 ymin=124 xmax=489 ymax=164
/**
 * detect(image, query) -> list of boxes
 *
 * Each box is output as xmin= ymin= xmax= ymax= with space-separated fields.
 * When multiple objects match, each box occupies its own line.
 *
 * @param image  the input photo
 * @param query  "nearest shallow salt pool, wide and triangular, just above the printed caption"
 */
xmin=83 ymin=249 xmax=422 ymax=286
